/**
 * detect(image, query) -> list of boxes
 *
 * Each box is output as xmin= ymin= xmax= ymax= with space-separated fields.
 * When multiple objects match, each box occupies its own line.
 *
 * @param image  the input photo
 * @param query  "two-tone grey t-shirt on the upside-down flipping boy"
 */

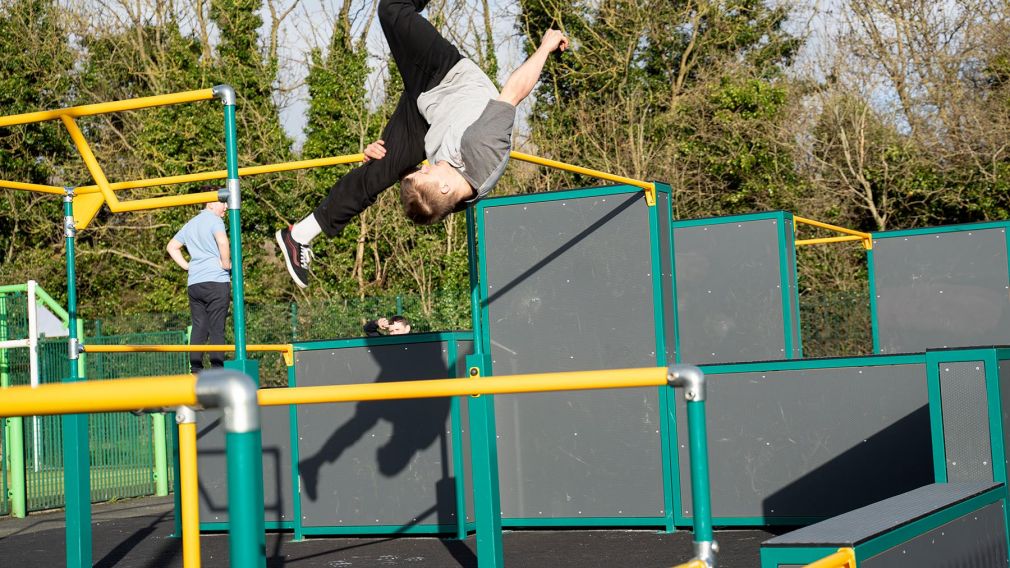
xmin=417 ymin=59 xmax=515 ymax=201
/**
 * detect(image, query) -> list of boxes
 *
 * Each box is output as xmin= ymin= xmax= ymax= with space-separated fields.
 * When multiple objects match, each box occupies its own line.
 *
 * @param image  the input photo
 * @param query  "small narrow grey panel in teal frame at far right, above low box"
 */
xmin=939 ymin=361 xmax=993 ymax=481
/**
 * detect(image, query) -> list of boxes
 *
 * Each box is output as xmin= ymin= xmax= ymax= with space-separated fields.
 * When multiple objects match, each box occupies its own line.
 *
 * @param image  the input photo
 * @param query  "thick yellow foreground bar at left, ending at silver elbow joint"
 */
xmin=0 ymin=375 xmax=197 ymax=416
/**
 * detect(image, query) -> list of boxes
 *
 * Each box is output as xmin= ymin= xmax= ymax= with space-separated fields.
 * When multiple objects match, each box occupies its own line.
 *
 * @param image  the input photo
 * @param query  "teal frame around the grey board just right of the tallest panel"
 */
xmin=670 ymin=211 xmax=803 ymax=363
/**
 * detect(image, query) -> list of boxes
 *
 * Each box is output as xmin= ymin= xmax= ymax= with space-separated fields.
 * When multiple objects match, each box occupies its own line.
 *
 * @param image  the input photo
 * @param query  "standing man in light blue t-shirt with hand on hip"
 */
xmin=168 ymin=201 xmax=231 ymax=373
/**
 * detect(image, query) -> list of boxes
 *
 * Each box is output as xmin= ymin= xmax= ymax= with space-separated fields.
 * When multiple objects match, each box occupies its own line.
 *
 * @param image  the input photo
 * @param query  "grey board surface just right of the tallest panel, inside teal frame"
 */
xmin=674 ymin=219 xmax=787 ymax=364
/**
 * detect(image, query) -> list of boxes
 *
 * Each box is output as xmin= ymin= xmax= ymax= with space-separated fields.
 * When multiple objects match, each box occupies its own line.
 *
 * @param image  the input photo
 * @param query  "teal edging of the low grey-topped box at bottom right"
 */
xmin=761 ymin=486 xmax=1006 ymax=568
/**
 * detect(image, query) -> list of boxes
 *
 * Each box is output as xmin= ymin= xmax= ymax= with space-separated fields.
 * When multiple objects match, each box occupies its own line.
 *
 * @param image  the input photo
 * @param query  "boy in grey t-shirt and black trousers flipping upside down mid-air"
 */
xmin=277 ymin=0 xmax=569 ymax=288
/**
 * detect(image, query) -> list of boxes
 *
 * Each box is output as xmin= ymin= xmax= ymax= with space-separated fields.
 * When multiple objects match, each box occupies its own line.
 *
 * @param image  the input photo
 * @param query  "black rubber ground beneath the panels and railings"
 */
xmin=0 ymin=498 xmax=773 ymax=568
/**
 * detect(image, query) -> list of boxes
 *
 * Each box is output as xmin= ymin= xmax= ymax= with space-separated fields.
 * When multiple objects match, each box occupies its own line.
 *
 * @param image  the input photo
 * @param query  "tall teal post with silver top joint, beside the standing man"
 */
xmin=214 ymin=85 xmax=260 ymax=382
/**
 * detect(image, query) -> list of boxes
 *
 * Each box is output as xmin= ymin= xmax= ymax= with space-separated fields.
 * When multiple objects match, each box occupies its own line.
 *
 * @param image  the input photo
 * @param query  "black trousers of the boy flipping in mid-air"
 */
xmin=314 ymin=0 xmax=463 ymax=236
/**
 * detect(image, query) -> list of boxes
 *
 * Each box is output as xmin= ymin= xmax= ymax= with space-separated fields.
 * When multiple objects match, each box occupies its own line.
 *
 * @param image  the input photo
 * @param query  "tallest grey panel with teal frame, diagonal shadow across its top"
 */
xmin=471 ymin=184 xmax=677 ymax=531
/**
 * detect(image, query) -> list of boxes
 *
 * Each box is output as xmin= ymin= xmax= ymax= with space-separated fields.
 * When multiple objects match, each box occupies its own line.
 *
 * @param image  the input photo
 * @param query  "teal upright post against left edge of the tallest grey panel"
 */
xmin=467 ymin=207 xmax=505 ymax=568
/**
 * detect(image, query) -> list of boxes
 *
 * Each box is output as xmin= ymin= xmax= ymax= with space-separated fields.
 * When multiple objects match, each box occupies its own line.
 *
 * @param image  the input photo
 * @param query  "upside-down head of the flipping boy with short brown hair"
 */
xmin=400 ymin=162 xmax=474 ymax=224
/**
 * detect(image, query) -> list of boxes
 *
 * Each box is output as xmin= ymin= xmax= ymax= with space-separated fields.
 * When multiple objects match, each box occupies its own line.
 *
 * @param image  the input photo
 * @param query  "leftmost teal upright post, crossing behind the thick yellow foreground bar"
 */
xmin=63 ymin=188 xmax=91 ymax=568
